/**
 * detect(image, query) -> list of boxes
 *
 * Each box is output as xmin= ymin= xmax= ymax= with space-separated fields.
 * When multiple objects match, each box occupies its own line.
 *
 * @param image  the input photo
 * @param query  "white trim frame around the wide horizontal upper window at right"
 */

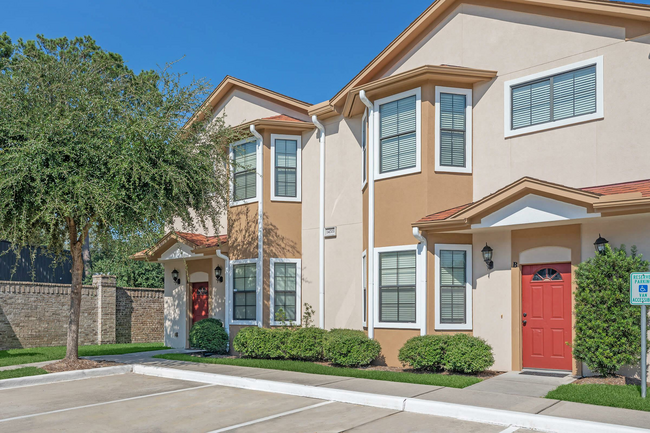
xmin=503 ymin=56 xmax=605 ymax=138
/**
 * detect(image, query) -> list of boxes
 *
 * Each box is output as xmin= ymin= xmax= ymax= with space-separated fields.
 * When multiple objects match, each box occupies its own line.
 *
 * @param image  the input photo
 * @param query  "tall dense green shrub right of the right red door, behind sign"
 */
xmin=573 ymin=245 xmax=648 ymax=375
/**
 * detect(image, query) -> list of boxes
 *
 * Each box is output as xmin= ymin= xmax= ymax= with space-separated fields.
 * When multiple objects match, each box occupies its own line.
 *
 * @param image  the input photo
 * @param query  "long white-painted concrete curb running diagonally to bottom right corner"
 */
xmin=133 ymin=364 xmax=648 ymax=433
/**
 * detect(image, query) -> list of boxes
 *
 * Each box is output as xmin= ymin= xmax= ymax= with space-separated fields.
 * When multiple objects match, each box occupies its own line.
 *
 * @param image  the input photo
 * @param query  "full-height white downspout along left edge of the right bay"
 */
xmin=359 ymin=90 xmax=375 ymax=338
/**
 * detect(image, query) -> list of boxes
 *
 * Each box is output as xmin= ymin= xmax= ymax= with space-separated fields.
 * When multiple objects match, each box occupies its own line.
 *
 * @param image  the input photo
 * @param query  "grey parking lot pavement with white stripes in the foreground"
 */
xmin=0 ymin=374 xmax=523 ymax=433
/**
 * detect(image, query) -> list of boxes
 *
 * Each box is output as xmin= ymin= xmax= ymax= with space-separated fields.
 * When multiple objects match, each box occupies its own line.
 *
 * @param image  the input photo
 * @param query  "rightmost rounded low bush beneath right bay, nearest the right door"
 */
xmin=442 ymin=334 xmax=494 ymax=374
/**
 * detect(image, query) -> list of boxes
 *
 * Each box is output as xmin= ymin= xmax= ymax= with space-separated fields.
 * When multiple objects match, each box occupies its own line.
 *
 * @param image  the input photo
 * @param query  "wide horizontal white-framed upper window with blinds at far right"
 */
xmin=505 ymin=56 xmax=603 ymax=137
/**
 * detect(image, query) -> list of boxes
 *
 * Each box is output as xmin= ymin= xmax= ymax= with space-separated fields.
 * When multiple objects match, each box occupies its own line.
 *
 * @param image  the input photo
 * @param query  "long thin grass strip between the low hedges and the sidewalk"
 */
xmin=154 ymin=353 xmax=481 ymax=388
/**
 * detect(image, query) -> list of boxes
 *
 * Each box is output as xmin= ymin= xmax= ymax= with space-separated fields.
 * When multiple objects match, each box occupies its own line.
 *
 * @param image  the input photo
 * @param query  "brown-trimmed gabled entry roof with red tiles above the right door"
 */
xmin=413 ymin=177 xmax=650 ymax=232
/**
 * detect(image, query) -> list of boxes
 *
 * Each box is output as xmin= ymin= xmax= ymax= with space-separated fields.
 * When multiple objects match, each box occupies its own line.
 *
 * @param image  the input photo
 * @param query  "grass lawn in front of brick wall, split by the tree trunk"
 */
xmin=0 ymin=343 xmax=169 ymax=367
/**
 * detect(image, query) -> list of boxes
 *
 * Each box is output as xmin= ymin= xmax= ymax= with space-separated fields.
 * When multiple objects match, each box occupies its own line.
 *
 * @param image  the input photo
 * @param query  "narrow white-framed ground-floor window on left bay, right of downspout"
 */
xmin=270 ymin=259 xmax=301 ymax=325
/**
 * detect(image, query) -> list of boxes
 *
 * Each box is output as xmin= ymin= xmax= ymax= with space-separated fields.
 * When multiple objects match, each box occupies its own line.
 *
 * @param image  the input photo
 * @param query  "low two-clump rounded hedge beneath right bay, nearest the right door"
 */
xmin=398 ymin=334 xmax=494 ymax=374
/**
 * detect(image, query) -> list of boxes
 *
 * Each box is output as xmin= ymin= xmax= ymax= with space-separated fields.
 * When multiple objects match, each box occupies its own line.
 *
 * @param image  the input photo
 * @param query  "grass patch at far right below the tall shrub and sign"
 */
xmin=546 ymin=384 xmax=650 ymax=411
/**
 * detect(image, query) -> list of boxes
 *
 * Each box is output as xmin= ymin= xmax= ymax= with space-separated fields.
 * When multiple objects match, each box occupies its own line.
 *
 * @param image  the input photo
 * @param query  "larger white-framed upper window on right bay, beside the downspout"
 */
xmin=375 ymin=87 xmax=421 ymax=179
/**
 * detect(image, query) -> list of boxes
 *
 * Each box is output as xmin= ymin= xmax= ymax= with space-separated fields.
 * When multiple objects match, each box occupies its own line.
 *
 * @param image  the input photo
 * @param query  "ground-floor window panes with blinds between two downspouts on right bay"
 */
xmin=379 ymin=251 xmax=417 ymax=323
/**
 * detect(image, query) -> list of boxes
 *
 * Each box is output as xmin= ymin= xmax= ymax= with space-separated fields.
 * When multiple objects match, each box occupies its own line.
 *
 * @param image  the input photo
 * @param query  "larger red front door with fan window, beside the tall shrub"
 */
xmin=521 ymin=263 xmax=571 ymax=370
